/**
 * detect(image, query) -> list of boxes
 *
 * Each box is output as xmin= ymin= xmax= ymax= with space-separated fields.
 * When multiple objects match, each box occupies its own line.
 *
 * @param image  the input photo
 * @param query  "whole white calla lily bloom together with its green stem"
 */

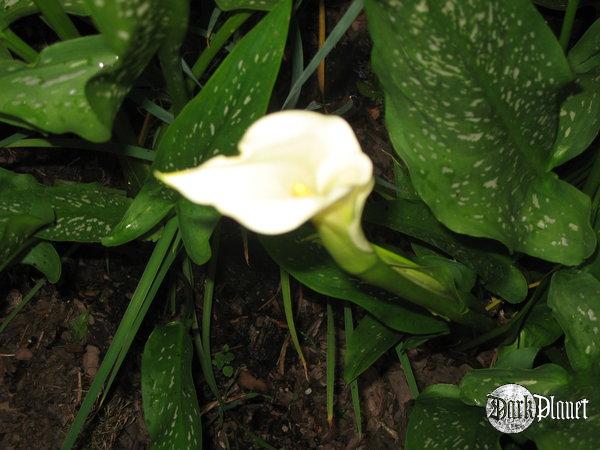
xmin=155 ymin=111 xmax=488 ymax=327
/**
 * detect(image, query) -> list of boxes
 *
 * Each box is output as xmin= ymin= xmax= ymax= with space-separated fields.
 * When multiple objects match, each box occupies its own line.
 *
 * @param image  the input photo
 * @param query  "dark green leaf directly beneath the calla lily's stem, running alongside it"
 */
xmin=261 ymin=227 xmax=448 ymax=334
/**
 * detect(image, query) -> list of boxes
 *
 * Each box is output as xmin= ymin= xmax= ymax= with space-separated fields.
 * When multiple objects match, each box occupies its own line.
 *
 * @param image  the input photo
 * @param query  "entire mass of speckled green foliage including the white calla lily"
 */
xmin=0 ymin=0 xmax=600 ymax=449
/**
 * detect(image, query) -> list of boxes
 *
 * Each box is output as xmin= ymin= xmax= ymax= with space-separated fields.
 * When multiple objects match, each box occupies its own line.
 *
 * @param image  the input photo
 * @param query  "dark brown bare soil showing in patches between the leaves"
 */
xmin=0 ymin=7 xmax=480 ymax=450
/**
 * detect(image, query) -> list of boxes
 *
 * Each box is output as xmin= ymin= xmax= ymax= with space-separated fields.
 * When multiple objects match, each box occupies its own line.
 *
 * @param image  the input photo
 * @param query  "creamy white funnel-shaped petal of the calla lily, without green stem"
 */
xmin=156 ymin=111 xmax=373 ymax=241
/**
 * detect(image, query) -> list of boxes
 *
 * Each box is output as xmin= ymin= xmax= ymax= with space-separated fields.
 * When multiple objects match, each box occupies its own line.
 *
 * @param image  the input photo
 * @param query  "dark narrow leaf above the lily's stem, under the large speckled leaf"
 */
xmin=365 ymin=200 xmax=527 ymax=303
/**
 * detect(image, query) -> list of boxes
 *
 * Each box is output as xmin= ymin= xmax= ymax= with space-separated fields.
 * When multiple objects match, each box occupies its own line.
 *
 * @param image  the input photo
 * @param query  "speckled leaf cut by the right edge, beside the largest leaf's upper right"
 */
xmin=551 ymin=20 xmax=600 ymax=166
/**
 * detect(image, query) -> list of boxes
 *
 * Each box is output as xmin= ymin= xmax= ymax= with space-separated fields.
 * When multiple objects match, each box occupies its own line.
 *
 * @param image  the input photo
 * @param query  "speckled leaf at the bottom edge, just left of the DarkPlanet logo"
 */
xmin=404 ymin=385 xmax=501 ymax=450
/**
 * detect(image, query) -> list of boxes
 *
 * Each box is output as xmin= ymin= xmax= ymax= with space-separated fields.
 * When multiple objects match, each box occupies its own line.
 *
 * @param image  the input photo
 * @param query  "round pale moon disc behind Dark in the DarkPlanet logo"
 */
xmin=485 ymin=384 xmax=536 ymax=433
